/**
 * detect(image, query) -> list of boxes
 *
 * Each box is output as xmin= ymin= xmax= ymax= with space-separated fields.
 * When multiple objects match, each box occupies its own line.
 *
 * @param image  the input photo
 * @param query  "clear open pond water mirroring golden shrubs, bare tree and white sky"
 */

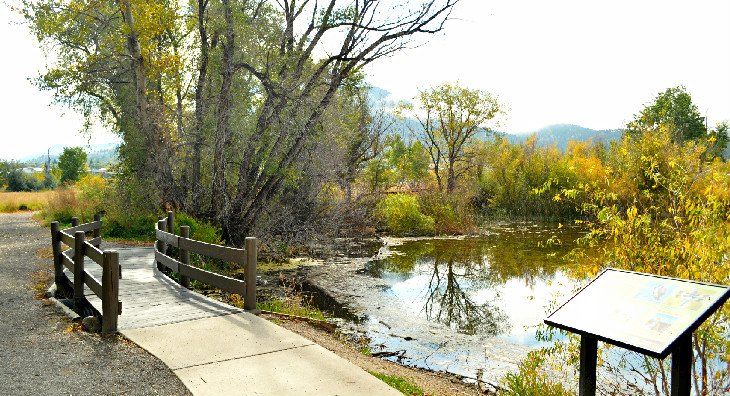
xmin=367 ymin=227 xmax=580 ymax=344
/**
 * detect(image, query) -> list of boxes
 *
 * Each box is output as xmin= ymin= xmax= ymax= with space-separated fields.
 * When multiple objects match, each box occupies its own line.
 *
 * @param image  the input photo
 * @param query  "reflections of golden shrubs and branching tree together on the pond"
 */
xmin=370 ymin=230 xmax=575 ymax=335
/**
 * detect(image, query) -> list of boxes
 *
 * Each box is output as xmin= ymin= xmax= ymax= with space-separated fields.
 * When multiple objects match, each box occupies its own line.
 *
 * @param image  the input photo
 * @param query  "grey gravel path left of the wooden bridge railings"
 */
xmin=0 ymin=213 xmax=190 ymax=396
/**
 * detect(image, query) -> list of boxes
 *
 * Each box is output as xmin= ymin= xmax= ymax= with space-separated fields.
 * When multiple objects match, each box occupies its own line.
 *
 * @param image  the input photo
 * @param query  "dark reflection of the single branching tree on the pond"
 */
xmin=424 ymin=252 xmax=509 ymax=335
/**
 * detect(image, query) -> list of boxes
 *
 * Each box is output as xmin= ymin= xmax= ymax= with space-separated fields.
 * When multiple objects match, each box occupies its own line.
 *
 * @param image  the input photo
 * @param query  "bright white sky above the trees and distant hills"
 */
xmin=0 ymin=0 xmax=730 ymax=159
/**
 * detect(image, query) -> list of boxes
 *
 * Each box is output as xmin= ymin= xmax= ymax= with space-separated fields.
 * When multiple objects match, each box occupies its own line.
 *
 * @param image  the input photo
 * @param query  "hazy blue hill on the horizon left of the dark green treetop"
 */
xmin=505 ymin=124 xmax=623 ymax=150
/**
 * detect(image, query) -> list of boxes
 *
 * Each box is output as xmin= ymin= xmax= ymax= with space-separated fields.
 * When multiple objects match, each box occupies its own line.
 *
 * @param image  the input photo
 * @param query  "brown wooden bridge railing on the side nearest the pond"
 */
xmin=155 ymin=212 xmax=257 ymax=311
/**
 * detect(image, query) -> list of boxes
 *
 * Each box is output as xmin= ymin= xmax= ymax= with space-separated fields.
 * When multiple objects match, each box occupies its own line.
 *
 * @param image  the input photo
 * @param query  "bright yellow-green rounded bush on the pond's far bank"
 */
xmin=376 ymin=194 xmax=435 ymax=235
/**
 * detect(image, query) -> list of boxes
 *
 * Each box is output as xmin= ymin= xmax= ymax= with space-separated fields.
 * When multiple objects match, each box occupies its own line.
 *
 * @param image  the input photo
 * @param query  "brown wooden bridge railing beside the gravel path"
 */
xmin=51 ymin=215 xmax=122 ymax=333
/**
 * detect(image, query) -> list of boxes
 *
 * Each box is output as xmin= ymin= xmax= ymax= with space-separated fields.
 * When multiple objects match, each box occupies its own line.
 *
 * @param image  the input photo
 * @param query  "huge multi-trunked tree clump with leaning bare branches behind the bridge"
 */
xmin=21 ymin=0 xmax=458 ymax=244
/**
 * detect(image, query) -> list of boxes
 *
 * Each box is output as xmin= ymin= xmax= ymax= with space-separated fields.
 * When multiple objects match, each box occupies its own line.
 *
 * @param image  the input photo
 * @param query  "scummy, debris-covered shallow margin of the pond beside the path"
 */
xmin=261 ymin=237 xmax=530 ymax=391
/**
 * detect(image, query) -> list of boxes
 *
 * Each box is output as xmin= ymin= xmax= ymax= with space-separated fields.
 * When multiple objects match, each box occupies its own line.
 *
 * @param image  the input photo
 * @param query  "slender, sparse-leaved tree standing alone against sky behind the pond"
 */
xmin=410 ymin=84 xmax=501 ymax=193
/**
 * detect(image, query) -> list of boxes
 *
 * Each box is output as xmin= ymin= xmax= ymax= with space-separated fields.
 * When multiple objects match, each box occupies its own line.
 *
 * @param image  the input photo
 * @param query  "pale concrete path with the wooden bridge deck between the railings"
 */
xmin=87 ymin=248 xmax=400 ymax=395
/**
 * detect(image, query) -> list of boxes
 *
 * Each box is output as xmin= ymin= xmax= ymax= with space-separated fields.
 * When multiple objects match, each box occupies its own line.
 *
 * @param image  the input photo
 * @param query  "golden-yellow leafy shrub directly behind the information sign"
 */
xmin=536 ymin=128 xmax=730 ymax=394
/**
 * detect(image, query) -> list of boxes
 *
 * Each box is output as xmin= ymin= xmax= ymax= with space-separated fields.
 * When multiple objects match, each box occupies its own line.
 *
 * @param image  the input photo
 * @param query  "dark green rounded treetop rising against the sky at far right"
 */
xmin=626 ymin=86 xmax=707 ymax=143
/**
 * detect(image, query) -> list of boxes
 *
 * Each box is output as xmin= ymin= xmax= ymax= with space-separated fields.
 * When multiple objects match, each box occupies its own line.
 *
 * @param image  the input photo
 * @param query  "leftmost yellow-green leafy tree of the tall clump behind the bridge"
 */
xmin=21 ymin=0 xmax=185 ymax=206
